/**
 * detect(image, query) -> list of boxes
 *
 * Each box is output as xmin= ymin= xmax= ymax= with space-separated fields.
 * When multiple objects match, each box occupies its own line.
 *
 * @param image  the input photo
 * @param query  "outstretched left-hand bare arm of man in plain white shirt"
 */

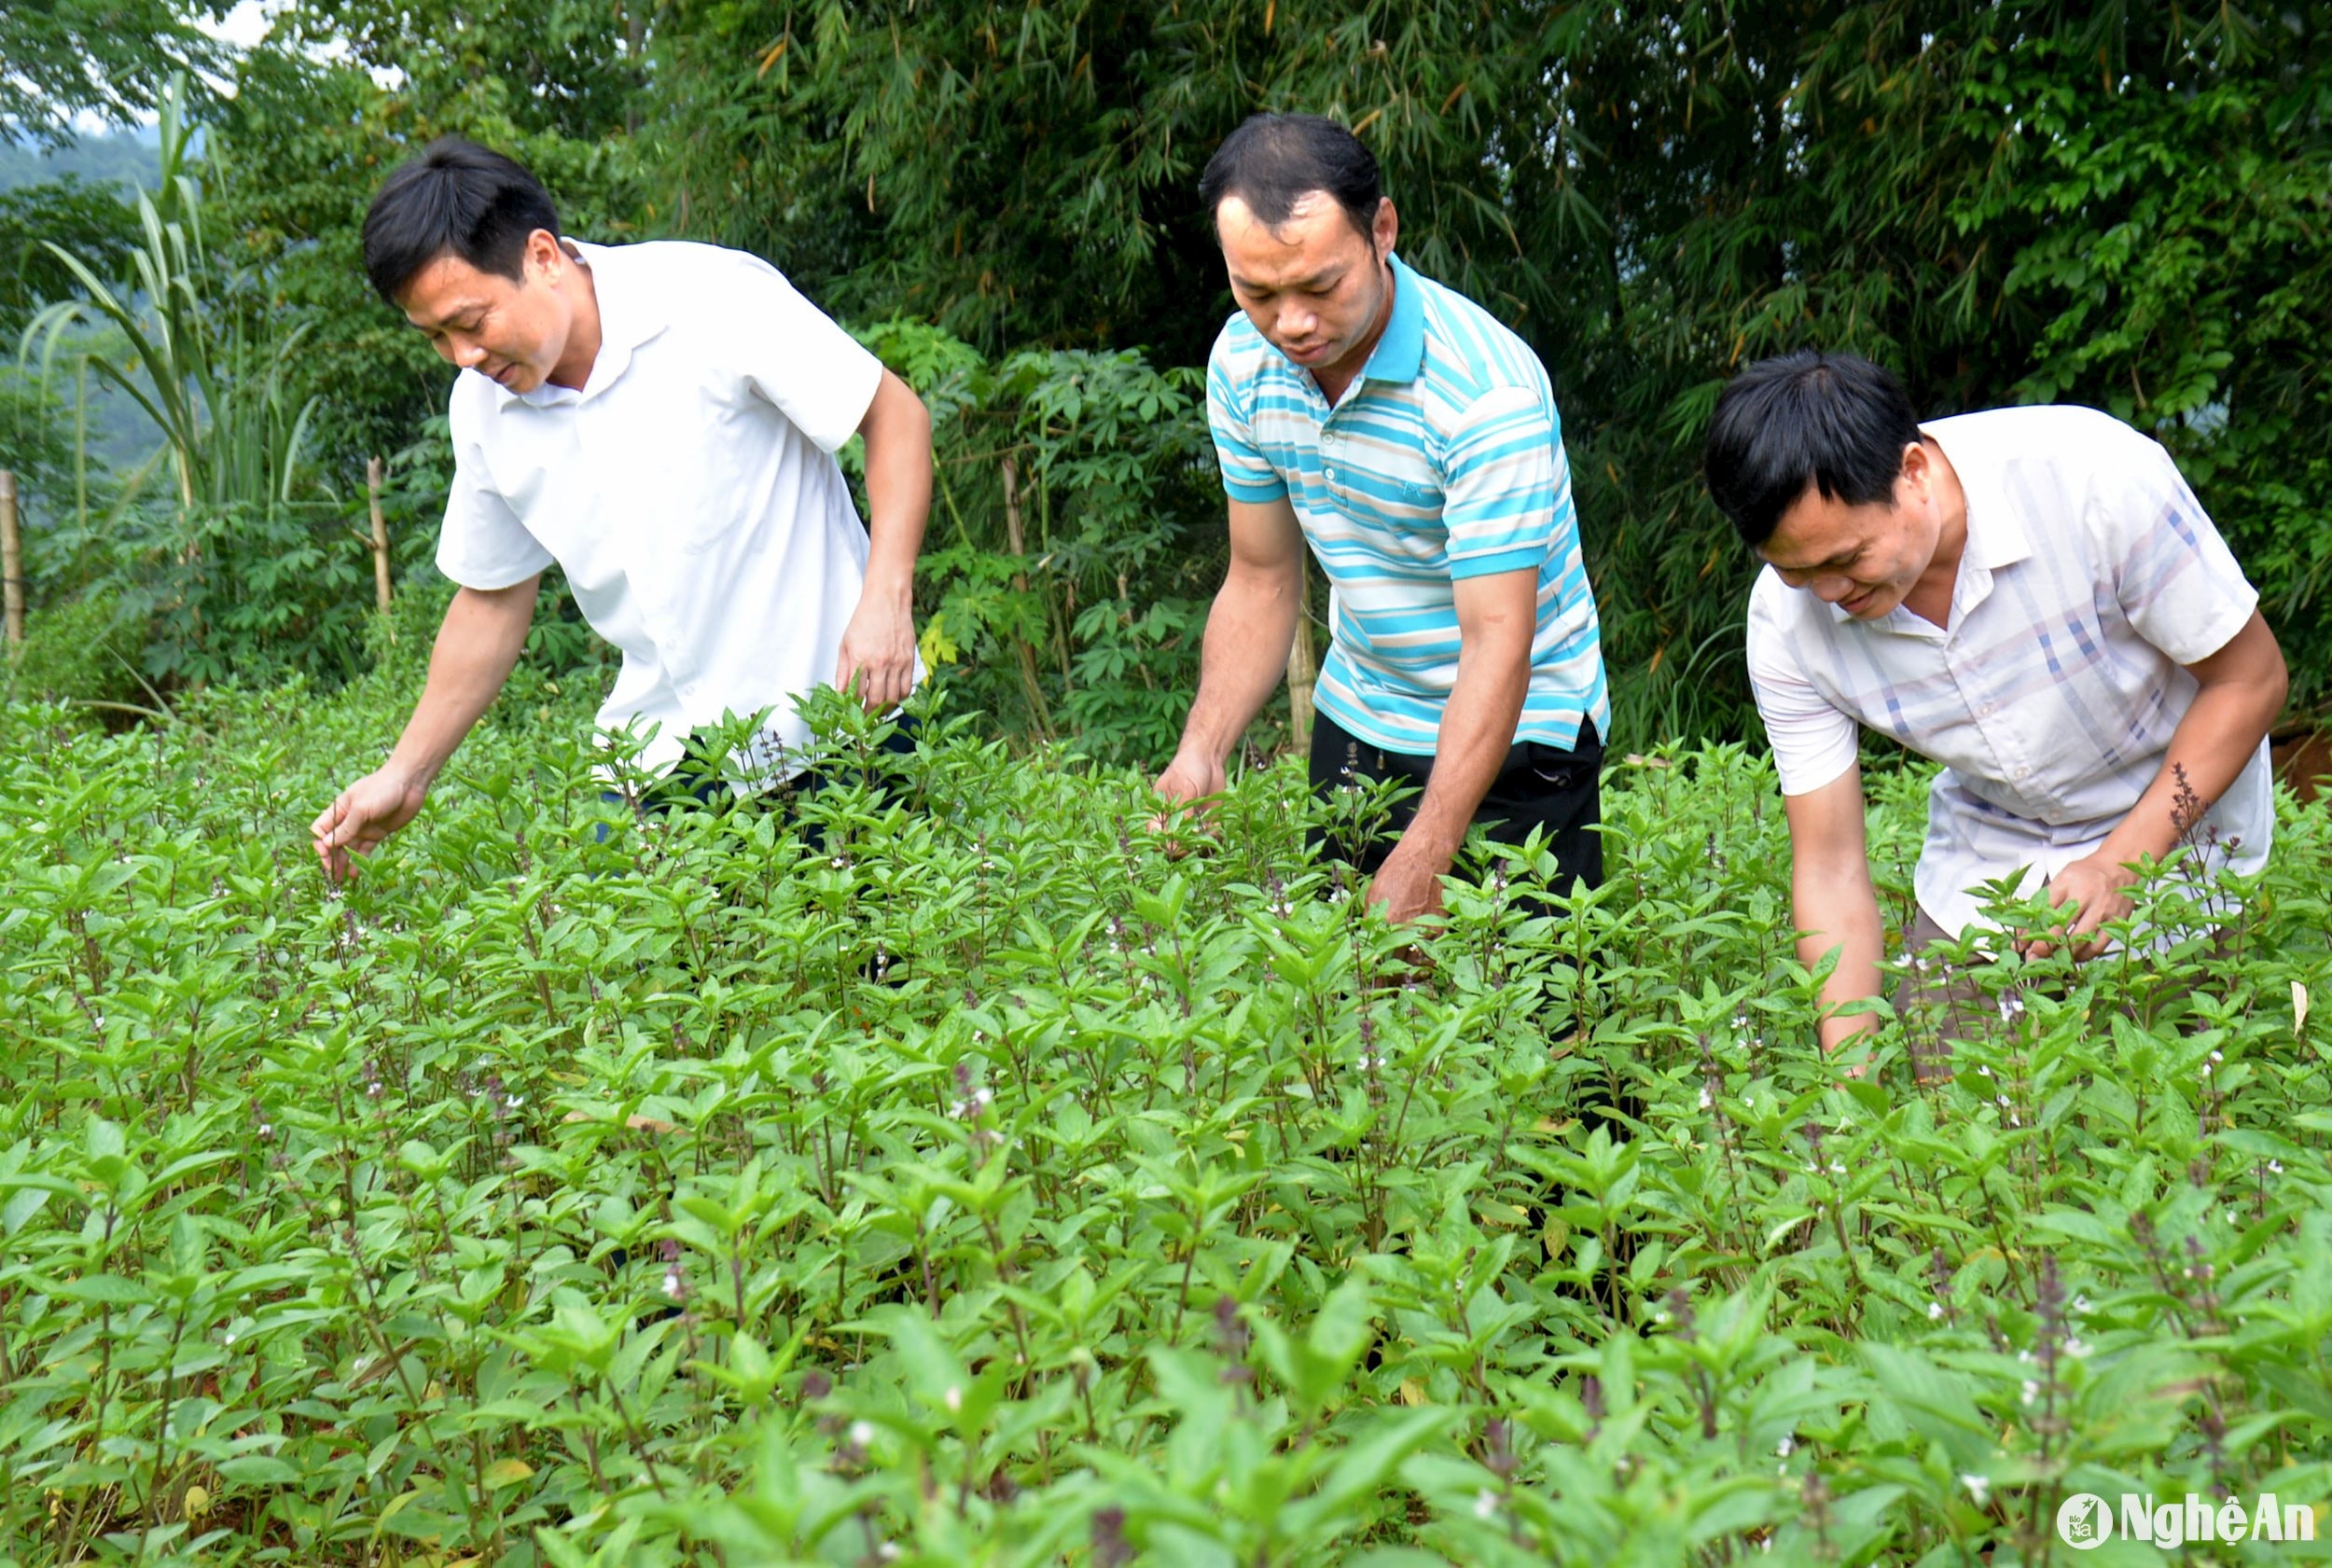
xmin=308 ymin=572 xmax=544 ymax=882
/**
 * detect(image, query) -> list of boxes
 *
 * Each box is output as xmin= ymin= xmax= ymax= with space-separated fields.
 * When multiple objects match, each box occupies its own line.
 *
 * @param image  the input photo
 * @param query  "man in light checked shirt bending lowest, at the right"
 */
xmin=1707 ymin=350 xmax=2285 ymax=1063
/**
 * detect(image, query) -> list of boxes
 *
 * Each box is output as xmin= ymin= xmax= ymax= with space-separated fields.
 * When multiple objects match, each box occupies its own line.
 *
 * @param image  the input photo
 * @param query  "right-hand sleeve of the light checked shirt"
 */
xmin=2094 ymin=432 xmax=2260 ymax=665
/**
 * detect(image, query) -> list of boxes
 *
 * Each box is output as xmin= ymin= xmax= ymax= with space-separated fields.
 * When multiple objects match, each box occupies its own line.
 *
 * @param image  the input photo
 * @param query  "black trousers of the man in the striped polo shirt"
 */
xmin=1311 ymin=714 xmax=1603 ymax=889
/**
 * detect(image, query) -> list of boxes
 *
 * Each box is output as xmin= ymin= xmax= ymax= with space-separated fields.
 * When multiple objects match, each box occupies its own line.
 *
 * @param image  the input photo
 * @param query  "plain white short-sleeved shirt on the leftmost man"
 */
xmin=438 ymin=241 xmax=923 ymax=784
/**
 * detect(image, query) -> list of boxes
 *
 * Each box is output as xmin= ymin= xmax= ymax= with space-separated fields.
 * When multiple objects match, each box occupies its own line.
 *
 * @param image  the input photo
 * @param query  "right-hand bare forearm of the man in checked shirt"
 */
xmin=2027 ymin=611 xmax=2290 ymax=959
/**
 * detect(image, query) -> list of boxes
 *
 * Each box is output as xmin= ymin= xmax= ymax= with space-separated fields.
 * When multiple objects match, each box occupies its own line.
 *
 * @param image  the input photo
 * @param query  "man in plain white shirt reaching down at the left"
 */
xmin=311 ymin=138 xmax=931 ymax=878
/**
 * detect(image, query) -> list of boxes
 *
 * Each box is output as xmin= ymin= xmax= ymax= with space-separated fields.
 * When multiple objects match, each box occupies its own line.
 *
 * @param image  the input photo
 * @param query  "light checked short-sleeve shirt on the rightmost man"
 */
xmin=1749 ymin=409 xmax=2274 ymax=931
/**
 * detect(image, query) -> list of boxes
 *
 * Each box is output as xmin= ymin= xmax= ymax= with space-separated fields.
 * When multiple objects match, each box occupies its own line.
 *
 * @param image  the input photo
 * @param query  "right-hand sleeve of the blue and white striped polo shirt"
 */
xmin=1441 ymin=387 xmax=1575 ymax=578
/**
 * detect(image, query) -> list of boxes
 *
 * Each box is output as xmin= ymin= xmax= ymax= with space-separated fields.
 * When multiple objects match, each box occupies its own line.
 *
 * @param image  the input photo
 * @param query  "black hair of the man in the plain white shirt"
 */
xmin=364 ymin=135 xmax=560 ymax=303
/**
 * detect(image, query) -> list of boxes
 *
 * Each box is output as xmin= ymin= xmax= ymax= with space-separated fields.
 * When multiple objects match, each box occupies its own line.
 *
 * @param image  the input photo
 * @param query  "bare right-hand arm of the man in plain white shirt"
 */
xmin=835 ymin=371 xmax=931 ymax=712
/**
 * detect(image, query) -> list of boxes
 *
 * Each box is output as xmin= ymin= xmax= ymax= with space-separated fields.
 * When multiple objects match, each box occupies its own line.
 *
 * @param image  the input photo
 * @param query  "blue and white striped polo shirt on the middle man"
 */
xmin=1206 ymin=257 xmax=1612 ymax=756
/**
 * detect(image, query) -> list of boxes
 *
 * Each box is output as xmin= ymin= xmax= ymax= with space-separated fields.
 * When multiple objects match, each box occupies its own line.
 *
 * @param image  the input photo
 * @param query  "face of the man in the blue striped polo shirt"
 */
xmin=1215 ymin=191 xmax=1399 ymax=376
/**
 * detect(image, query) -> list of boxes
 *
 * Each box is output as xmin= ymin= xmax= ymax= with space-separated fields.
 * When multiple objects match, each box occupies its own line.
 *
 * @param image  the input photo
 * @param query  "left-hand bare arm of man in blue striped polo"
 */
xmin=1157 ymin=494 xmax=1304 ymax=805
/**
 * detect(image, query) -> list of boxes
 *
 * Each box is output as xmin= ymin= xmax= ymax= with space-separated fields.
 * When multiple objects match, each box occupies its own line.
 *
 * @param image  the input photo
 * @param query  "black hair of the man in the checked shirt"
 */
xmin=1700 ymin=348 xmax=1920 ymax=550
